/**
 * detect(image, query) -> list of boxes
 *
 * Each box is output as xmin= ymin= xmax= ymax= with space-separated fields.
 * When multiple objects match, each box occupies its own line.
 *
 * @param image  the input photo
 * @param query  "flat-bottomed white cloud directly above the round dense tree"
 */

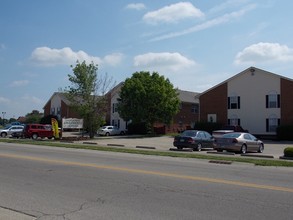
xmin=134 ymin=52 xmax=196 ymax=72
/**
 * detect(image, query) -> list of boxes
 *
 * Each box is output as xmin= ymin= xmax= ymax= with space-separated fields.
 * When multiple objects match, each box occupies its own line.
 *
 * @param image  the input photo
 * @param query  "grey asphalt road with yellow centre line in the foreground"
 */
xmin=0 ymin=143 xmax=293 ymax=220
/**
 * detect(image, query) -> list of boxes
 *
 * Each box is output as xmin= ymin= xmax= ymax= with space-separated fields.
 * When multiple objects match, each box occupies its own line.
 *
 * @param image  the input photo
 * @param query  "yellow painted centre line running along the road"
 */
xmin=0 ymin=154 xmax=293 ymax=193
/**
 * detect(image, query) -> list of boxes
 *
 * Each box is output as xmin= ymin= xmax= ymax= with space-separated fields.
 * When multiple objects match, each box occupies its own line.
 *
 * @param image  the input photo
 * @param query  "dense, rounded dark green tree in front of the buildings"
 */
xmin=118 ymin=71 xmax=180 ymax=132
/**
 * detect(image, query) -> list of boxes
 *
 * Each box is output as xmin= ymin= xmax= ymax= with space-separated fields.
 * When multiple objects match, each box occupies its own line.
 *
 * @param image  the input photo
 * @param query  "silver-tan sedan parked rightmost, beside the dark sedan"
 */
xmin=214 ymin=132 xmax=264 ymax=154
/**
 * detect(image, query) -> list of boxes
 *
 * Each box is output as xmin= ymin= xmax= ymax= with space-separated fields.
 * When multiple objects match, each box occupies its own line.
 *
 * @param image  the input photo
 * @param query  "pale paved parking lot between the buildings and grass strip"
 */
xmin=65 ymin=133 xmax=293 ymax=159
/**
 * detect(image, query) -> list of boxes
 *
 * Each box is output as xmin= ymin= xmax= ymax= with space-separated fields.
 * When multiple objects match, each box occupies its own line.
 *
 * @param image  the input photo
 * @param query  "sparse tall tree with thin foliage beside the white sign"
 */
xmin=66 ymin=61 xmax=113 ymax=138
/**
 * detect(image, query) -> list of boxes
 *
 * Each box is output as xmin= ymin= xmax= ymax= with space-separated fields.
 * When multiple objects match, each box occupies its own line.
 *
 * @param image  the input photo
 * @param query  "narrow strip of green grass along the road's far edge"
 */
xmin=0 ymin=139 xmax=293 ymax=167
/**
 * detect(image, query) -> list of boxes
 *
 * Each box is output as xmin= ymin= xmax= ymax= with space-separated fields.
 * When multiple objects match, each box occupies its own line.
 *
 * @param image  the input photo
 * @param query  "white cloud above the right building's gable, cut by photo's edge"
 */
xmin=234 ymin=42 xmax=293 ymax=64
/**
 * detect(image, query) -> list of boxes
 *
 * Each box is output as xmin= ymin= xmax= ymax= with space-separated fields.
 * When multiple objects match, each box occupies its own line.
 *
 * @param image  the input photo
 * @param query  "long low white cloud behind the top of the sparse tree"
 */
xmin=30 ymin=47 xmax=122 ymax=66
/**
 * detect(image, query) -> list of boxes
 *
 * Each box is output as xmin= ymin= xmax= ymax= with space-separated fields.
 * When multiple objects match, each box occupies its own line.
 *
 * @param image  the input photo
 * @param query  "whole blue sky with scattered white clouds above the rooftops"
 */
xmin=0 ymin=0 xmax=293 ymax=118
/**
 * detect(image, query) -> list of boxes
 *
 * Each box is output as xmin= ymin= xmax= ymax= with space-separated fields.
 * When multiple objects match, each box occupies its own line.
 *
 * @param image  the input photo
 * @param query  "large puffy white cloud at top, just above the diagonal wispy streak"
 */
xmin=143 ymin=2 xmax=204 ymax=24
